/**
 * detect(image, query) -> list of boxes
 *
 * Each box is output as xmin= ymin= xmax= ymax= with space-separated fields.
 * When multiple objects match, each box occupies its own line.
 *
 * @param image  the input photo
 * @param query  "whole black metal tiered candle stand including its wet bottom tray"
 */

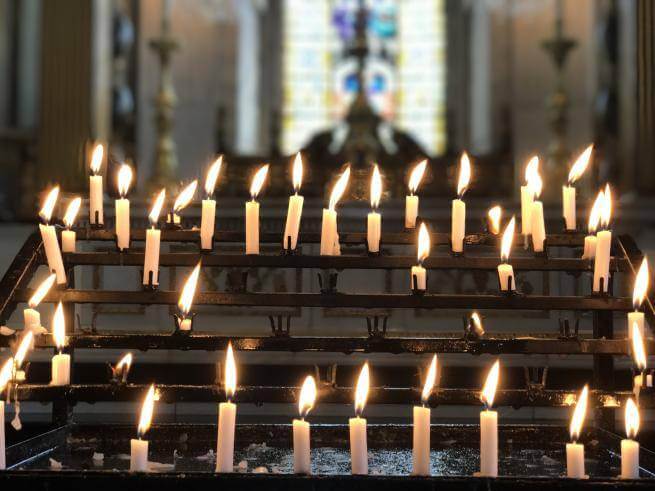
xmin=0 ymin=227 xmax=655 ymax=491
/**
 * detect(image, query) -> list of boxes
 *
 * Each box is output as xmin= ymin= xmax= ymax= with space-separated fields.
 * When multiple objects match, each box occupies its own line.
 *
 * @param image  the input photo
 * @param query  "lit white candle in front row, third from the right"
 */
xmin=480 ymin=360 xmax=500 ymax=477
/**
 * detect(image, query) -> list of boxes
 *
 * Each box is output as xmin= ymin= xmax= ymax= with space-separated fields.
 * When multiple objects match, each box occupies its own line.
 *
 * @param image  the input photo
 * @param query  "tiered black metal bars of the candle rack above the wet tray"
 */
xmin=0 ymin=228 xmax=655 ymax=488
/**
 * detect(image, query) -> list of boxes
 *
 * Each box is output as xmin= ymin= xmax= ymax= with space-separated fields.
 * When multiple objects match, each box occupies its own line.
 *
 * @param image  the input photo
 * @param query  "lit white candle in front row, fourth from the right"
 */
xmin=412 ymin=355 xmax=437 ymax=476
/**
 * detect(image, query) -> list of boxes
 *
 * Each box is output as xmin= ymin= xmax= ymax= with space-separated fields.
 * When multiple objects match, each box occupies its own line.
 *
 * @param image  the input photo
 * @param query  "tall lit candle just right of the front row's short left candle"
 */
xmin=216 ymin=343 xmax=237 ymax=472
